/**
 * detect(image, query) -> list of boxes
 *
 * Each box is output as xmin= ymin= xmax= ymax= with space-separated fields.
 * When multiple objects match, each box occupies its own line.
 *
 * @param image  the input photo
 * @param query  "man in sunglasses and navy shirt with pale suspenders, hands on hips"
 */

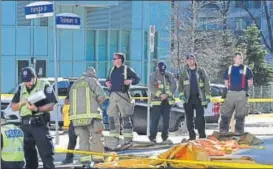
xmin=105 ymin=53 xmax=140 ymax=150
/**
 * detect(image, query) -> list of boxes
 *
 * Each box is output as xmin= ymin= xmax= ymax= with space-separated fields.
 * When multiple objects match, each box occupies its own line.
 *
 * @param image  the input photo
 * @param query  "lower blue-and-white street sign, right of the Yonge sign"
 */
xmin=56 ymin=13 xmax=81 ymax=29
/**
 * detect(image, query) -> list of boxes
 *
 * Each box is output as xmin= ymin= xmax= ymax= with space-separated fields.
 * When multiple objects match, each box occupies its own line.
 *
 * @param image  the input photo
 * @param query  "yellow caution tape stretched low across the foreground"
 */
xmin=55 ymin=148 xmax=273 ymax=168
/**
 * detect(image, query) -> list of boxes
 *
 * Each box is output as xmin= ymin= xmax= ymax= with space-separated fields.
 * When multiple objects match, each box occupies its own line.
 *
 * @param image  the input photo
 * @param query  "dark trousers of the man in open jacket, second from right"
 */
xmin=184 ymin=96 xmax=206 ymax=140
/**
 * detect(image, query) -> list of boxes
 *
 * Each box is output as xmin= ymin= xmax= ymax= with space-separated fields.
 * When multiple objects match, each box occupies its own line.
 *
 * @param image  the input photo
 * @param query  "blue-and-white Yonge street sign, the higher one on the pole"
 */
xmin=25 ymin=1 xmax=54 ymax=19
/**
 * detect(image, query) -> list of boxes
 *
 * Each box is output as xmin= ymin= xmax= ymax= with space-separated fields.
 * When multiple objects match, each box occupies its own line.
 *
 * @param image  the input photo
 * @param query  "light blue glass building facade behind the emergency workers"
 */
xmin=1 ymin=1 xmax=273 ymax=92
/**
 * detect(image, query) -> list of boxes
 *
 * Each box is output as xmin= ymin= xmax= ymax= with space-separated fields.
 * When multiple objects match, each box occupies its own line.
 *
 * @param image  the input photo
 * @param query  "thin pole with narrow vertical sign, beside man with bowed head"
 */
xmin=147 ymin=25 xmax=155 ymax=136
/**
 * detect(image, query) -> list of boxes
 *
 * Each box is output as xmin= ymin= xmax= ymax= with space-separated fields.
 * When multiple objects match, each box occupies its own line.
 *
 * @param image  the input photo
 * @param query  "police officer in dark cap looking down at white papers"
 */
xmin=11 ymin=67 xmax=57 ymax=169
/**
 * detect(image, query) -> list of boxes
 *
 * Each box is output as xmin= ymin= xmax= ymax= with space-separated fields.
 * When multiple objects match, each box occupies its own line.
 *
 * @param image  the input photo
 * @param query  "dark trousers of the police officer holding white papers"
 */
xmin=21 ymin=124 xmax=55 ymax=169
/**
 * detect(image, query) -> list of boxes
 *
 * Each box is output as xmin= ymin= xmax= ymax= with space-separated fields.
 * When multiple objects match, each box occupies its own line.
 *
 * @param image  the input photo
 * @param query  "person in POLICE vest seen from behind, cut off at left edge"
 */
xmin=1 ymin=111 xmax=25 ymax=169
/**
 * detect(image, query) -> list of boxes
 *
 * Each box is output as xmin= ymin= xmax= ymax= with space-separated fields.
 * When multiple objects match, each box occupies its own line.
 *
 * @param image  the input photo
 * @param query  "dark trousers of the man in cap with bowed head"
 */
xmin=149 ymin=102 xmax=171 ymax=141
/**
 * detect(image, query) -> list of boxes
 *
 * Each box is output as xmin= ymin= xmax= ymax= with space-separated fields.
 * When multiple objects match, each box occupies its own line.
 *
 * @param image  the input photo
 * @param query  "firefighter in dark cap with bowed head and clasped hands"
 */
xmin=149 ymin=62 xmax=177 ymax=143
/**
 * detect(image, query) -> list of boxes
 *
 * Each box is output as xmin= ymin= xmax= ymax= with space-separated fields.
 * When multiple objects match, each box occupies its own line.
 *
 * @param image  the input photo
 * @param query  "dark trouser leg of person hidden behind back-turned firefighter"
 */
xmin=66 ymin=121 xmax=77 ymax=158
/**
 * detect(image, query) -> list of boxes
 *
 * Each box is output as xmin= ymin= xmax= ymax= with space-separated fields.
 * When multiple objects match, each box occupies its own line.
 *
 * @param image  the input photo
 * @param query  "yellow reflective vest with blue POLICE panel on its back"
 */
xmin=1 ymin=124 xmax=24 ymax=162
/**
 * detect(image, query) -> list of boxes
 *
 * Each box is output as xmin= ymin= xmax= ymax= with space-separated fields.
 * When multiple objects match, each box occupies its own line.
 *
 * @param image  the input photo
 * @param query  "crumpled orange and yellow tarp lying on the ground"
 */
xmin=95 ymin=136 xmax=253 ymax=168
